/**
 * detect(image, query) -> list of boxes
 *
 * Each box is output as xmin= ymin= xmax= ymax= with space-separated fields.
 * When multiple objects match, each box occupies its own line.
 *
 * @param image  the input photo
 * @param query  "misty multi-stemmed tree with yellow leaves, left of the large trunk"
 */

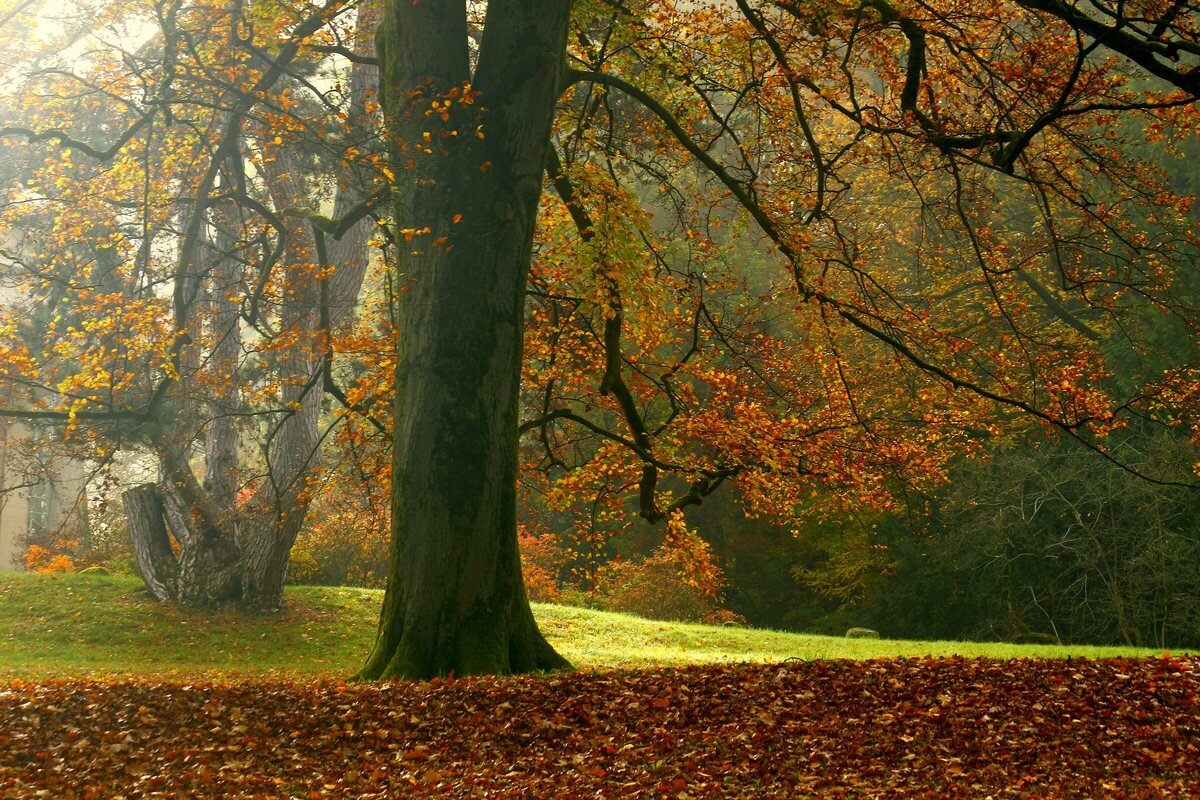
xmin=5 ymin=1 xmax=380 ymax=610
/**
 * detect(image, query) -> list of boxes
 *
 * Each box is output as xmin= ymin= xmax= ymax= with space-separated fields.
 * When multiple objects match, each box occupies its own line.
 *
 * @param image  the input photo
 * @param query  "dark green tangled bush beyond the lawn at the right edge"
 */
xmin=852 ymin=432 xmax=1200 ymax=648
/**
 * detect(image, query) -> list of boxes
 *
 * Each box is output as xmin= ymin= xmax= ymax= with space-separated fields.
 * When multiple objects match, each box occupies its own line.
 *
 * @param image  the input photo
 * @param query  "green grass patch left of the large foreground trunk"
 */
xmin=0 ymin=573 xmax=379 ymax=676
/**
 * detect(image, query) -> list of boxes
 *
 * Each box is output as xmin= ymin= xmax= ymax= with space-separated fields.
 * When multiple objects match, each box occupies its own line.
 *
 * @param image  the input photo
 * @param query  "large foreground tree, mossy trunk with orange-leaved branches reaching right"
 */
xmin=361 ymin=0 xmax=1198 ymax=678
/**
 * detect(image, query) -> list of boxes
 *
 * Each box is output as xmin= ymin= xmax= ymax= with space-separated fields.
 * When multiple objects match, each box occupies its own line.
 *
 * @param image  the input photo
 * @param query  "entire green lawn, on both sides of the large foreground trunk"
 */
xmin=0 ymin=573 xmax=1180 ymax=680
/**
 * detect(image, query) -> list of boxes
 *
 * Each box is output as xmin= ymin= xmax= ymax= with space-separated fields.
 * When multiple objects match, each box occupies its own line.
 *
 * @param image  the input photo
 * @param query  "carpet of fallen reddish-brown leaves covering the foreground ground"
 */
xmin=0 ymin=657 xmax=1200 ymax=799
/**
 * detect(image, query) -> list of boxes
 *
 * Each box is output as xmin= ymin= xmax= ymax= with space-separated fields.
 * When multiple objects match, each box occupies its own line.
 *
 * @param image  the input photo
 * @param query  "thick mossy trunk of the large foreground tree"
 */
xmin=360 ymin=0 xmax=570 ymax=679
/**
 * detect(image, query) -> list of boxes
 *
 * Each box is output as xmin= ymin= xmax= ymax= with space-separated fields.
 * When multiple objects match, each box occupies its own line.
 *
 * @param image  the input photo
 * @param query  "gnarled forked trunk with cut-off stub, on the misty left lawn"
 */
xmin=125 ymin=0 xmax=380 ymax=612
